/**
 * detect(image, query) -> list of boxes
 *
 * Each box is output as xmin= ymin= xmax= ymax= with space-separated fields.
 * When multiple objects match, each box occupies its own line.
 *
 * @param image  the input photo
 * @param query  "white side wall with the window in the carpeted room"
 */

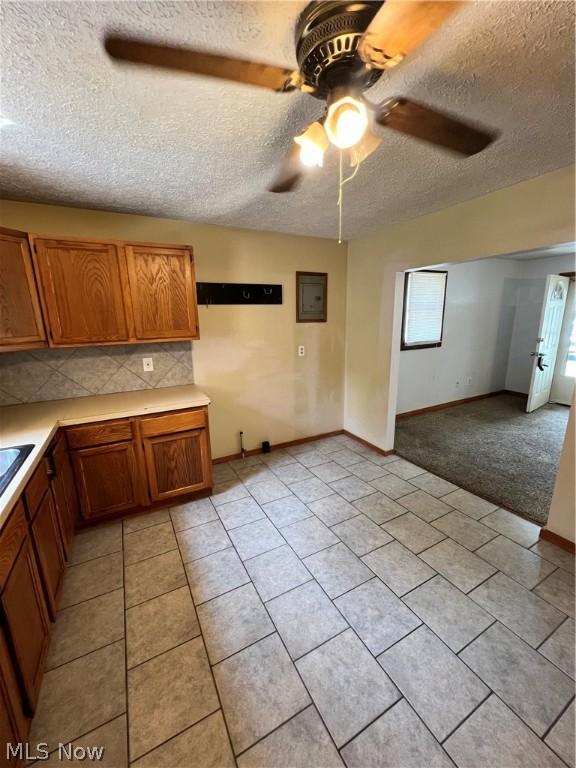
xmin=398 ymin=259 xmax=519 ymax=413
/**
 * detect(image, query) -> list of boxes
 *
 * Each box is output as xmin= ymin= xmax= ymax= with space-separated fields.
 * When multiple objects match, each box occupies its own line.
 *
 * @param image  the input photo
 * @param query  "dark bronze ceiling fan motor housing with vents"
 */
xmin=296 ymin=0 xmax=382 ymax=99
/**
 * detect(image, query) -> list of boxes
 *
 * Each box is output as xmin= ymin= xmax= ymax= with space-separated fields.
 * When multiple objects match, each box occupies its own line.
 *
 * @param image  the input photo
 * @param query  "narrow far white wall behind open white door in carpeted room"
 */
xmin=505 ymin=255 xmax=574 ymax=394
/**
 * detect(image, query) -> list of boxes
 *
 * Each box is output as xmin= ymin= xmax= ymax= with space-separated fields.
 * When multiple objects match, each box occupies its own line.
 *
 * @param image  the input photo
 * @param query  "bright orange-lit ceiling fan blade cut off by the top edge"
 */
xmin=358 ymin=0 xmax=463 ymax=69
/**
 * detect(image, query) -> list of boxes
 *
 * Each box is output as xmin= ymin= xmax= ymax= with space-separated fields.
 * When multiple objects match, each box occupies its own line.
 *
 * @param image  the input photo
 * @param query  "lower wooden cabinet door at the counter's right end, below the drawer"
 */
xmin=142 ymin=428 xmax=212 ymax=501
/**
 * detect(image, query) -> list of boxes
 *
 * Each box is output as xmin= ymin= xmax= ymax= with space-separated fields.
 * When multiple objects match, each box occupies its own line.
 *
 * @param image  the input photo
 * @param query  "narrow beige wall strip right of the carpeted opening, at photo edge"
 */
xmin=546 ymin=398 xmax=576 ymax=541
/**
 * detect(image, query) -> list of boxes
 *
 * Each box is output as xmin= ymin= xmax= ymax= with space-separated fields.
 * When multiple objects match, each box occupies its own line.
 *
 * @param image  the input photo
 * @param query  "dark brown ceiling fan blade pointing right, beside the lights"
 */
xmin=376 ymin=98 xmax=497 ymax=156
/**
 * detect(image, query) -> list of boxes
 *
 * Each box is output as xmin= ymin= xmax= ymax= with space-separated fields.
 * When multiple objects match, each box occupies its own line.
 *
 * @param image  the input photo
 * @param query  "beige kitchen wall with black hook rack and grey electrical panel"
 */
xmin=0 ymin=201 xmax=346 ymax=457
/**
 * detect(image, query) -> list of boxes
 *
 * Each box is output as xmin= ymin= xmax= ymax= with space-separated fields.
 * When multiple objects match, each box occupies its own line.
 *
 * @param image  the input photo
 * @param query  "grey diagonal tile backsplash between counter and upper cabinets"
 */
xmin=0 ymin=341 xmax=194 ymax=405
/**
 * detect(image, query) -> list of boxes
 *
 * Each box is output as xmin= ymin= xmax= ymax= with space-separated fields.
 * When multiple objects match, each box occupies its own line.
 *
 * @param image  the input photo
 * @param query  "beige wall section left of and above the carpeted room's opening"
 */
xmin=344 ymin=167 xmax=576 ymax=449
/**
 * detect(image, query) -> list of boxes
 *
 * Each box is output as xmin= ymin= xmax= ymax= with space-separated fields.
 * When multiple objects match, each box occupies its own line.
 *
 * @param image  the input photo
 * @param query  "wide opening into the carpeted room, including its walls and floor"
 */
xmin=394 ymin=244 xmax=576 ymax=525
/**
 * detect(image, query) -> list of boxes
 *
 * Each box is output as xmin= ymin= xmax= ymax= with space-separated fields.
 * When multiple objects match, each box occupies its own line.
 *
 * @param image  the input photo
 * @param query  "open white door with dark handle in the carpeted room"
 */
xmin=526 ymin=275 xmax=570 ymax=413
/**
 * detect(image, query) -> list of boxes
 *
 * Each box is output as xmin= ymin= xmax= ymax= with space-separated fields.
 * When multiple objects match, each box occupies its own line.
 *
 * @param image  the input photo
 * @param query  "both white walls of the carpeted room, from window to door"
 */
xmin=397 ymin=256 xmax=574 ymax=413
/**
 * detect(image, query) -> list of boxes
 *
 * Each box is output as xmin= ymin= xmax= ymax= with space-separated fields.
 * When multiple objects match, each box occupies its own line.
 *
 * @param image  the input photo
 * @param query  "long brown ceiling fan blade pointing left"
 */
xmin=104 ymin=35 xmax=302 ymax=91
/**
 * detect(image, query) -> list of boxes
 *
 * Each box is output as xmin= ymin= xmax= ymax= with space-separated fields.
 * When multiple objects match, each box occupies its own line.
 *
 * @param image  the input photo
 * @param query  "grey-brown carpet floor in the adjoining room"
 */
xmin=396 ymin=394 xmax=570 ymax=525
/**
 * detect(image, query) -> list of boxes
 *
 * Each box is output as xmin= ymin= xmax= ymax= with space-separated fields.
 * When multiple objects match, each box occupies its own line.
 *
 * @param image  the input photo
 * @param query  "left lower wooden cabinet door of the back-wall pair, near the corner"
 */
xmin=72 ymin=442 xmax=140 ymax=518
